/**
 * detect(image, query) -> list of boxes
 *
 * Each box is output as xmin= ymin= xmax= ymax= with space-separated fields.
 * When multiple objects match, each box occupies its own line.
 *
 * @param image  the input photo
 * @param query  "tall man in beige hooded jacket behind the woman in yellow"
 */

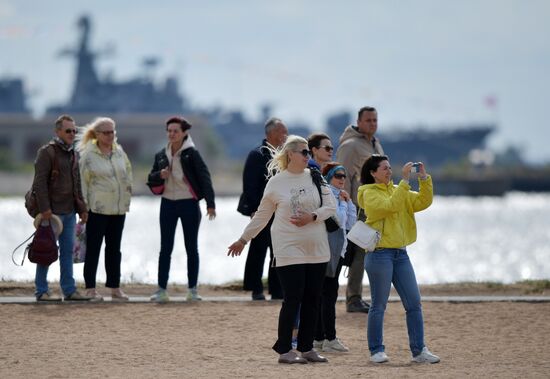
xmin=336 ymin=107 xmax=384 ymax=313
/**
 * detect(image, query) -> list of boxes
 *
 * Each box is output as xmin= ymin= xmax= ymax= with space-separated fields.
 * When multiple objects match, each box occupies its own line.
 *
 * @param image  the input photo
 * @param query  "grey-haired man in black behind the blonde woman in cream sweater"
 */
xmin=237 ymin=117 xmax=288 ymax=300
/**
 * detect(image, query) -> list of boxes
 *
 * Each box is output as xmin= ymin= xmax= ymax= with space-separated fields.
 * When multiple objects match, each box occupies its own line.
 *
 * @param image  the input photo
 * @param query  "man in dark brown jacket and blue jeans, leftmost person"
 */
xmin=33 ymin=115 xmax=90 ymax=301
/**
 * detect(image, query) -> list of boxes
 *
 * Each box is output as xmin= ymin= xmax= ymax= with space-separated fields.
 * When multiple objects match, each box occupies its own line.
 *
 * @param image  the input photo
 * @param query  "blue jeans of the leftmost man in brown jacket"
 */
xmin=34 ymin=212 xmax=76 ymax=297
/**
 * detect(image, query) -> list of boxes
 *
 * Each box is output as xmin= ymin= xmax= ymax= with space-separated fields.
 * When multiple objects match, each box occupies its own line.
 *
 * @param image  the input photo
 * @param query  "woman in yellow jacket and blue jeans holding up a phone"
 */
xmin=357 ymin=155 xmax=439 ymax=363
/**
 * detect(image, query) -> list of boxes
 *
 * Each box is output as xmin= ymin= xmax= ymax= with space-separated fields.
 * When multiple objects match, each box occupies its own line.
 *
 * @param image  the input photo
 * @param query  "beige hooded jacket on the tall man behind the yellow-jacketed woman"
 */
xmin=336 ymin=125 xmax=384 ymax=206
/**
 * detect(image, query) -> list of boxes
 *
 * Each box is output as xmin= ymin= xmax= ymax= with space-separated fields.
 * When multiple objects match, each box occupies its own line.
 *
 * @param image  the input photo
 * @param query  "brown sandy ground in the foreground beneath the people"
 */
xmin=0 ymin=283 xmax=550 ymax=379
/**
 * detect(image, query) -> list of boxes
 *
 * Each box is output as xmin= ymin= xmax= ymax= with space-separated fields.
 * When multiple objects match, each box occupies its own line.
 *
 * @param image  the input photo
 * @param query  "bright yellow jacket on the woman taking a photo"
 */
xmin=357 ymin=176 xmax=433 ymax=248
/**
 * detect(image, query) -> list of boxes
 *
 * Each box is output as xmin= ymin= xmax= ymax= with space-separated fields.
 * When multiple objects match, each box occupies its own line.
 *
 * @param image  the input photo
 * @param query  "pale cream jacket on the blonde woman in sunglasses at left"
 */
xmin=80 ymin=140 xmax=133 ymax=215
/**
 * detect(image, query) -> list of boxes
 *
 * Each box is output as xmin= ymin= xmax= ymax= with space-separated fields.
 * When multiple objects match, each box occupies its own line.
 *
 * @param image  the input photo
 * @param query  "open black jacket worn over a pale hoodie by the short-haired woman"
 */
xmin=147 ymin=147 xmax=216 ymax=208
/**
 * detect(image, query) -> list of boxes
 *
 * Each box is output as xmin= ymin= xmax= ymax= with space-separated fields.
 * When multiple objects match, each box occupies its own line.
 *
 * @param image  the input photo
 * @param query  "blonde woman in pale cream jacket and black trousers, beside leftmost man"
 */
xmin=77 ymin=117 xmax=132 ymax=301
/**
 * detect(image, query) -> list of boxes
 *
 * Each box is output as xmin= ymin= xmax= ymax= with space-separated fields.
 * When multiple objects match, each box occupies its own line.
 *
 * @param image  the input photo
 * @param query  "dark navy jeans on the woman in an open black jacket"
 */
xmin=158 ymin=198 xmax=202 ymax=289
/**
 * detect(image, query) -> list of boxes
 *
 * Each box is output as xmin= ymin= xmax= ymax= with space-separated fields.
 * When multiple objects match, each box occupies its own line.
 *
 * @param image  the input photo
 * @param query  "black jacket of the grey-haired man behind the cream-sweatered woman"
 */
xmin=237 ymin=139 xmax=271 ymax=216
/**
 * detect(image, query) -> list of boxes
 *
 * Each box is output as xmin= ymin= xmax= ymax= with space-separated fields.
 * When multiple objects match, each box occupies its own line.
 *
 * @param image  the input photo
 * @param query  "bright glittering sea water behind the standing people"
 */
xmin=0 ymin=193 xmax=550 ymax=284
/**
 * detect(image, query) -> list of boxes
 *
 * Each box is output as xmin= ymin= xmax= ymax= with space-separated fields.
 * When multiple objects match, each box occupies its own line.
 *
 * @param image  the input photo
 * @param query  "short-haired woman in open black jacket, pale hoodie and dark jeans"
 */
xmin=148 ymin=117 xmax=216 ymax=302
